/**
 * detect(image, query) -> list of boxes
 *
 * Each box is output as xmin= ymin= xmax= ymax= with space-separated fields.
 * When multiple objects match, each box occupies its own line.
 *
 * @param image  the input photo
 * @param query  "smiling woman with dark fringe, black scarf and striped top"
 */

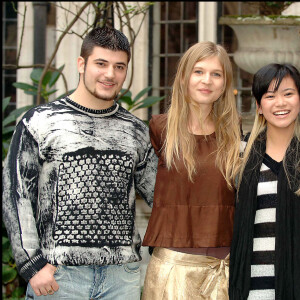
xmin=229 ymin=64 xmax=300 ymax=300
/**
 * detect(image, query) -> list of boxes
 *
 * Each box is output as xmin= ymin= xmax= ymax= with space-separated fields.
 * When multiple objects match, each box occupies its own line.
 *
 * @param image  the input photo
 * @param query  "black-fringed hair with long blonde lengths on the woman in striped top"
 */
xmin=237 ymin=64 xmax=300 ymax=196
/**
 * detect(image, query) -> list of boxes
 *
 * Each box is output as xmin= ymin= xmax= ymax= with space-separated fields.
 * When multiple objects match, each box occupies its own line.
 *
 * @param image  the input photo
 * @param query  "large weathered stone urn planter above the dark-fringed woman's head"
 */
xmin=219 ymin=2 xmax=300 ymax=74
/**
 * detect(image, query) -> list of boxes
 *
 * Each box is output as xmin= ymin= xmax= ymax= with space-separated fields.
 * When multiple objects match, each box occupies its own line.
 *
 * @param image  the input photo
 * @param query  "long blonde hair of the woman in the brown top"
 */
xmin=164 ymin=42 xmax=241 ymax=189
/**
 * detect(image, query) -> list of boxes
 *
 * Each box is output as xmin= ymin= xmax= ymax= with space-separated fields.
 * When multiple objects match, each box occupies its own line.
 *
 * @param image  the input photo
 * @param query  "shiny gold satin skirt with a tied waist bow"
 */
xmin=142 ymin=248 xmax=229 ymax=300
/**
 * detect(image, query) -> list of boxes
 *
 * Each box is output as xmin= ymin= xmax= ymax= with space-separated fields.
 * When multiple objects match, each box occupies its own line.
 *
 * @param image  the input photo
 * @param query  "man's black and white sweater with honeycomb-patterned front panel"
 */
xmin=3 ymin=98 xmax=157 ymax=280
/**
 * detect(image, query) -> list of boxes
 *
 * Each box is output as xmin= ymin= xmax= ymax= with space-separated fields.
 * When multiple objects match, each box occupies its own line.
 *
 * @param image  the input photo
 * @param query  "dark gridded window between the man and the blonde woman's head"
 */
xmin=149 ymin=2 xmax=198 ymax=114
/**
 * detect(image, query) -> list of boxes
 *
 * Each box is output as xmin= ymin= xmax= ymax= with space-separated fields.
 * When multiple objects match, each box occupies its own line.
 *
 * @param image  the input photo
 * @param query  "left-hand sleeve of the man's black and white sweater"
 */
xmin=2 ymin=121 xmax=47 ymax=281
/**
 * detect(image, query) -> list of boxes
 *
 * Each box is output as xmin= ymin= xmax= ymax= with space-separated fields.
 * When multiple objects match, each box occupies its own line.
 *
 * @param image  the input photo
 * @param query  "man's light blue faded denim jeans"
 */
xmin=25 ymin=262 xmax=141 ymax=300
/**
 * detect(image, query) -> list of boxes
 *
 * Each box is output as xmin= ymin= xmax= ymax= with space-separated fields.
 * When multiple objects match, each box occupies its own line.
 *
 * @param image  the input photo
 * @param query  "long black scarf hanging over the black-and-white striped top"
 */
xmin=229 ymin=131 xmax=300 ymax=300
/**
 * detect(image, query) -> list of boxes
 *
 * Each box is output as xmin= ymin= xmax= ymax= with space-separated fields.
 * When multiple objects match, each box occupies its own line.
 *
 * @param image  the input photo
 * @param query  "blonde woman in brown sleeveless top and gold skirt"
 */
xmin=143 ymin=42 xmax=240 ymax=300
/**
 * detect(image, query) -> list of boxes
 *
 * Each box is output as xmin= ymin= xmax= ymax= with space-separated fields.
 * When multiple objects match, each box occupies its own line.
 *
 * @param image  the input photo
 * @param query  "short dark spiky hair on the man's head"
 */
xmin=80 ymin=26 xmax=131 ymax=62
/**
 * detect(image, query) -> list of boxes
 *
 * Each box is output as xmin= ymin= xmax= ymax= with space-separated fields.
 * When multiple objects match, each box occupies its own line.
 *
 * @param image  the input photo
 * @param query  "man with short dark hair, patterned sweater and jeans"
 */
xmin=3 ymin=27 xmax=157 ymax=300
